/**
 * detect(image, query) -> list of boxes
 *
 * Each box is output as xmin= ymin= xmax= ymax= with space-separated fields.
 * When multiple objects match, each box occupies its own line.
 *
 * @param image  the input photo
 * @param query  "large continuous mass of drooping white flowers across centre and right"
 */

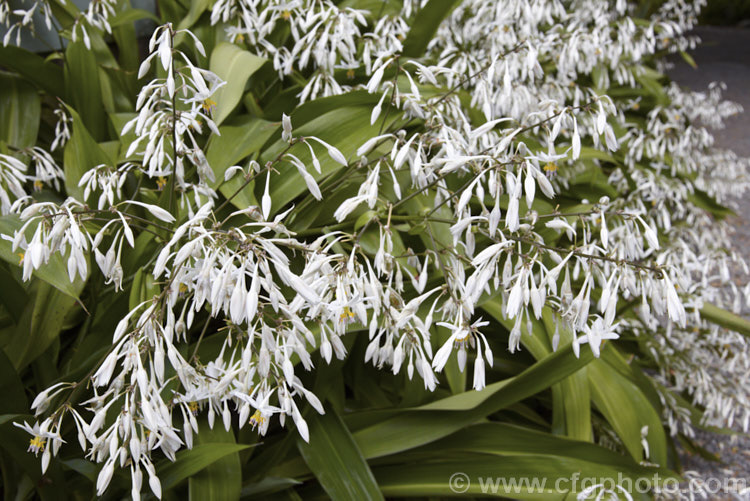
xmin=0 ymin=0 xmax=750 ymax=498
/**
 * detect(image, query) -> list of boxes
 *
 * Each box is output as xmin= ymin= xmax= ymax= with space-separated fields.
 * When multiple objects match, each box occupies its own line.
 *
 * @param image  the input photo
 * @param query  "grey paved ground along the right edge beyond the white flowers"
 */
xmin=669 ymin=27 xmax=750 ymax=500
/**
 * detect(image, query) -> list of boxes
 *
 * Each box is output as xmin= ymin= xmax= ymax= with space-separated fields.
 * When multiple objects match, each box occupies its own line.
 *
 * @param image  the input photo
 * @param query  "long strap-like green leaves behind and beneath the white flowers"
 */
xmin=0 ymin=0 xmax=750 ymax=500
